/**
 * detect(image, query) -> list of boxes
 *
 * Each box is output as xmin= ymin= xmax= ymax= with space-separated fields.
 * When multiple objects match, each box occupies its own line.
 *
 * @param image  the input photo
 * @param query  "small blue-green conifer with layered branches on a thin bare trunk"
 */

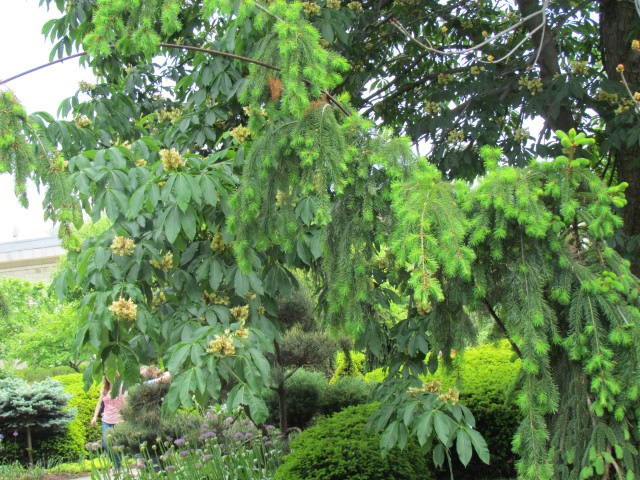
xmin=0 ymin=378 xmax=76 ymax=465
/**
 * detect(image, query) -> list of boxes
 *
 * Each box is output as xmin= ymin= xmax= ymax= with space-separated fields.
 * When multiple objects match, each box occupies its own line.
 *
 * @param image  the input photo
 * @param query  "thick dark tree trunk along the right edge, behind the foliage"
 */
xmin=600 ymin=0 xmax=640 ymax=275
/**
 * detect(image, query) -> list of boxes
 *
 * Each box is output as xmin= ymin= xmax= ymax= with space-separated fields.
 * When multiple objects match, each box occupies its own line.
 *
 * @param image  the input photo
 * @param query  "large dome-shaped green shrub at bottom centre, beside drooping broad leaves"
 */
xmin=275 ymin=404 xmax=431 ymax=480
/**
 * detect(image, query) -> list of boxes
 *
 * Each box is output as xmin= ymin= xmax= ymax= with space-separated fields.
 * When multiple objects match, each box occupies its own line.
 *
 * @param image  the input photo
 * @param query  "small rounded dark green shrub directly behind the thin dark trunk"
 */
xmin=266 ymin=368 xmax=329 ymax=429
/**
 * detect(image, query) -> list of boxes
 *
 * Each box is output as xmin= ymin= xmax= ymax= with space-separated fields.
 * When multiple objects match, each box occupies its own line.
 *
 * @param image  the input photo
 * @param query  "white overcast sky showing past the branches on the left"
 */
xmin=0 ymin=0 xmax=93 ymax=242
